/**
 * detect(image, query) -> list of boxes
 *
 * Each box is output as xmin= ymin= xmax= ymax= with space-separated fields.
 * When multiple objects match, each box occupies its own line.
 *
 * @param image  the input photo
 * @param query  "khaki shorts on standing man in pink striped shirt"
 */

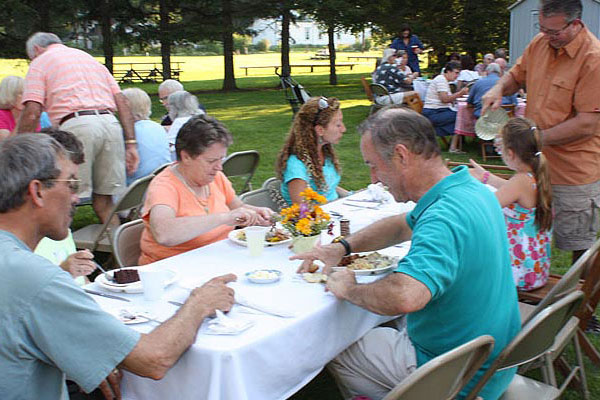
xmin=60 ymin=114 xmax=125 ymax=197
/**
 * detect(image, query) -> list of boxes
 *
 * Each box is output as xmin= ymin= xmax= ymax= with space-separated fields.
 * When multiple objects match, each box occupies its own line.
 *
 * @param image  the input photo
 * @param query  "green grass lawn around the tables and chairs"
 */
xmin=67 ymin=73 xmax=600 ymax=400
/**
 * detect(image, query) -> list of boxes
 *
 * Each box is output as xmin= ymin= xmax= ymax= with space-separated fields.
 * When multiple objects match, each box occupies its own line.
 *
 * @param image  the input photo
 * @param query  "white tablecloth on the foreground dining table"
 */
xmin=90 ymin=193 xmax=414 ymax=400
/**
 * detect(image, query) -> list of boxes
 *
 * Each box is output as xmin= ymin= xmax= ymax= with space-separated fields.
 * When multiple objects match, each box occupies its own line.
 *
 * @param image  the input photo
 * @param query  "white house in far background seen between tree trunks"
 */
xmin=251 ymin=19 xmax=371 ymax=46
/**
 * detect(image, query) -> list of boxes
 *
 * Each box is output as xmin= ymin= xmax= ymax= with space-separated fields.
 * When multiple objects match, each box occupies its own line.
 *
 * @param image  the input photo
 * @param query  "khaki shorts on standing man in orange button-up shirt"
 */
xmin=552 ymin=181 xmax=600 ymax=251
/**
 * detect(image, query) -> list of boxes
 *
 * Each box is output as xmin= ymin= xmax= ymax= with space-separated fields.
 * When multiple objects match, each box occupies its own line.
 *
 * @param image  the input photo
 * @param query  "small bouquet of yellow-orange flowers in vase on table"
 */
xmin=281 ymin=188 xmax=331 ymax=253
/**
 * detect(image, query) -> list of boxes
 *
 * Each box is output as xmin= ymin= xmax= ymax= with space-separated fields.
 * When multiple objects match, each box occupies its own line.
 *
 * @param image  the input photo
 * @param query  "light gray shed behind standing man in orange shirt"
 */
xmin=508 ymin=0 xmax=600 ymax=63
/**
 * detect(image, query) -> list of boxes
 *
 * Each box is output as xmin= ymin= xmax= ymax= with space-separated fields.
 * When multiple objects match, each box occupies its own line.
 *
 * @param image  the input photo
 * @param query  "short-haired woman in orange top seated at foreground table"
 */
xmin=139 ymin=115 xmax=272 ymax=265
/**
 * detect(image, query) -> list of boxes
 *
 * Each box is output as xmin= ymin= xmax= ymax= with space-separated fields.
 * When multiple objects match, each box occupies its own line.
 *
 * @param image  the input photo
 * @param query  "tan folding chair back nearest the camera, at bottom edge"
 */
xmin=383 ymin=335 xmax=494 ymax=400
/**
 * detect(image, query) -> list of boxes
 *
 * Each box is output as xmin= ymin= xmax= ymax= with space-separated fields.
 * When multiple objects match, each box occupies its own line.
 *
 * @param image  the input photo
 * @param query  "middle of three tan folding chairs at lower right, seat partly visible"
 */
xmin=465 ymin=290 xmax=583 ymax=400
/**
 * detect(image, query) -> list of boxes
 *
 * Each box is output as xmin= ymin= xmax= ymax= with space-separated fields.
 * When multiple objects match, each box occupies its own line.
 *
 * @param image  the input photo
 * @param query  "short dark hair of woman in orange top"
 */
xmin=175 ymin=114 xmax=233 ymax=161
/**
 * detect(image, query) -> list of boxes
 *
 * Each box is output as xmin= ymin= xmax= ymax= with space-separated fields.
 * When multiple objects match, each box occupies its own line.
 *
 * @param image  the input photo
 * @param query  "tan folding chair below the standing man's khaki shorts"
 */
xmin=73 ymin=175 xmax=154 ymax=253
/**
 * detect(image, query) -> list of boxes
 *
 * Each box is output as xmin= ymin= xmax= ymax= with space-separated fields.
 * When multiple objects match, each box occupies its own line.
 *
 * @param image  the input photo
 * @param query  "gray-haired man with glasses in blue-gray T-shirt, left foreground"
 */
xmin=0 ymin=134 xmax=235 ymax=400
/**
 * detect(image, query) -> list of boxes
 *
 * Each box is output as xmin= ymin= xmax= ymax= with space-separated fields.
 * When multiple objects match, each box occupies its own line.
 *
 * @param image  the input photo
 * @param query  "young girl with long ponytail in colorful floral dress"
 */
xmin=471 ymin=118 xmax=552 ymax=291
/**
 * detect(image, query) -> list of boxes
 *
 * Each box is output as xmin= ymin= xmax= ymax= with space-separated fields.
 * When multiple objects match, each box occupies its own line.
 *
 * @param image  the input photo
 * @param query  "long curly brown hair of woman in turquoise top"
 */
xmin=275 ymin=97 xmax=341 ymax=191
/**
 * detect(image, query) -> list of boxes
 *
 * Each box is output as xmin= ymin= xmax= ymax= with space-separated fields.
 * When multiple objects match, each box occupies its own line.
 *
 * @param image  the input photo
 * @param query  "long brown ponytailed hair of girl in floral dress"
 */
xmin=502 ymin=118 xmax=552 ymax=231
